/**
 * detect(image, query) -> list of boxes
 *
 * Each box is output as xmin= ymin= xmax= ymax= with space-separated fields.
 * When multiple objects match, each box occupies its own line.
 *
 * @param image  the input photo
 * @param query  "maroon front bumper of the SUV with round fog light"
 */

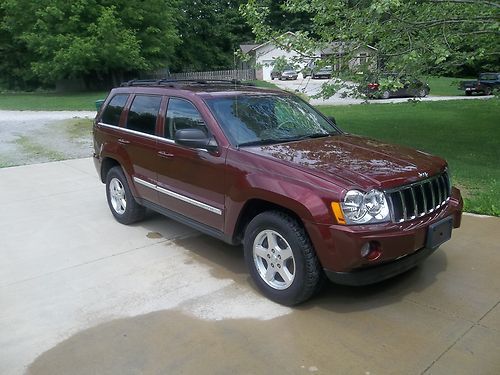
xmin=306 ymin=188 xmax=463 ymax=285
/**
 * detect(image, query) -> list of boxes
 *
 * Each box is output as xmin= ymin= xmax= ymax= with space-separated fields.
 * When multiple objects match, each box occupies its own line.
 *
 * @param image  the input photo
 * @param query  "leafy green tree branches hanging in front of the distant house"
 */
xmin=242 ymin=0 xmax=500 ymax=93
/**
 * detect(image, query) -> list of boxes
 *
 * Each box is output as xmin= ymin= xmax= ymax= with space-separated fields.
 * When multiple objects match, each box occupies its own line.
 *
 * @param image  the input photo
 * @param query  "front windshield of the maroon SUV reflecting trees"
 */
xmin=207 ymin=95 xmax=339 ymax=146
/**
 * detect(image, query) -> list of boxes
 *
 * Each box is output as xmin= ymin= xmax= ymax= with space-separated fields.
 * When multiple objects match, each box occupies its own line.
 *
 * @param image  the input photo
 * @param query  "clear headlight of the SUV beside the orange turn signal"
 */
xmin=340 ymin=190 xmax=390 ymax=224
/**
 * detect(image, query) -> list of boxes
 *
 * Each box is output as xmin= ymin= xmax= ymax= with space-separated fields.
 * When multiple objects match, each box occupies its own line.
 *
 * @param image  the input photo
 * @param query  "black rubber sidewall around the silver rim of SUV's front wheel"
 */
xmin=243 ymin=212 xmax=312 ymax=305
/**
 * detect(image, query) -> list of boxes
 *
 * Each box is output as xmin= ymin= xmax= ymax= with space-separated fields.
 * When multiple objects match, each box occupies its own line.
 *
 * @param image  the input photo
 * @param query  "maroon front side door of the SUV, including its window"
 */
xmin=158 ymin=98 xmax=225 ymax=231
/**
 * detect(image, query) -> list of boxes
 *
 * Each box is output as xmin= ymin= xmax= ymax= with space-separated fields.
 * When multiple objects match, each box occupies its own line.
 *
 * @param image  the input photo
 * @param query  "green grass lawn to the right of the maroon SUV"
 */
xmin=319 ymin=99 xmax=500 ymax=216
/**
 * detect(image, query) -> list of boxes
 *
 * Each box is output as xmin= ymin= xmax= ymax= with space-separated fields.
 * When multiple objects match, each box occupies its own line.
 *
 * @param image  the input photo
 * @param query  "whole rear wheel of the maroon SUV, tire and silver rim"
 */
xmin=106 ymin=167 xmax=146 ymax=224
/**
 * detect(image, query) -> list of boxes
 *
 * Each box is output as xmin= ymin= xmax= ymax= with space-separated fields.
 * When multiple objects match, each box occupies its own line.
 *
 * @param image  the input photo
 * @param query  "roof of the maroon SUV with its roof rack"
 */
xmin=115 ymin=79 xmax=287 ymax=97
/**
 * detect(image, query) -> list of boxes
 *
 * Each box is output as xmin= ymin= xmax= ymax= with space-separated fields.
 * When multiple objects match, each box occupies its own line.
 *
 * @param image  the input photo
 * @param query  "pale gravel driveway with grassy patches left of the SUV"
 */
xmin=0 ymin=111 xmax=95 ymax=167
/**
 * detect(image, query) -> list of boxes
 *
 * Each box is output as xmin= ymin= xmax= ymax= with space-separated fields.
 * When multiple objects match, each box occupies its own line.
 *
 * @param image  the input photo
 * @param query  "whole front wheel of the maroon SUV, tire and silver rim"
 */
xmin=243 ymin=211 xmax=324 ymax=306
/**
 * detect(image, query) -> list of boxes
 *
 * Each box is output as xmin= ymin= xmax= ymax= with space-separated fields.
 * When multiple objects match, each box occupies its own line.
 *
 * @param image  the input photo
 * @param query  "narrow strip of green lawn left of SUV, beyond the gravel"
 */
xmin=0 ymin=92 xmax=108 ymax=111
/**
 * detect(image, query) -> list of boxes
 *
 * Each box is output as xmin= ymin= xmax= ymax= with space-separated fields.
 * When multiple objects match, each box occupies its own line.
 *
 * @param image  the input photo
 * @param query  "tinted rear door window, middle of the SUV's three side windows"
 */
xmin=127 ymin=95 xmax=161 ymax=135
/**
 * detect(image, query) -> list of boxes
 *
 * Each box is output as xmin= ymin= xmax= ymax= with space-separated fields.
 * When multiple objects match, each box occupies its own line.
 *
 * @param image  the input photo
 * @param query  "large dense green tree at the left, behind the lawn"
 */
xmin=1 ymin=0 xmax=179 ymax=88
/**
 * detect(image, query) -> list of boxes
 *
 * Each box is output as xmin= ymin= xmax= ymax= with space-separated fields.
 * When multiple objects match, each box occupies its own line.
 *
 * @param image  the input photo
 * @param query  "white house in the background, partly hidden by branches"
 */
xmin=240 ymin=32 xmax=377 ymax=80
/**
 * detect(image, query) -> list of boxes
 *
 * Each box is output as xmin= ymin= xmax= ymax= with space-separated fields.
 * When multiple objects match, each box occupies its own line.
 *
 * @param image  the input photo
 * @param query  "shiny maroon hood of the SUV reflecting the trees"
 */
xmin=246 ymin=134 xmax=446 ymax=189
